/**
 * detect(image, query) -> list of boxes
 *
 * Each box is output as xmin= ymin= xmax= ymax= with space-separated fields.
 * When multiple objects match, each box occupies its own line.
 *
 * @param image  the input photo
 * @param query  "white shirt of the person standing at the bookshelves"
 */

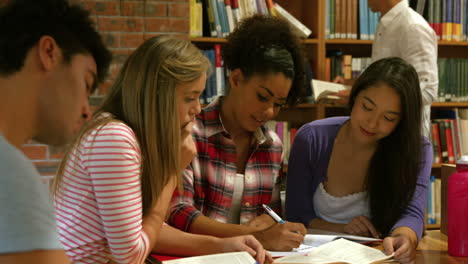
xmin=372 ymin=0 xmax=439 ymax=137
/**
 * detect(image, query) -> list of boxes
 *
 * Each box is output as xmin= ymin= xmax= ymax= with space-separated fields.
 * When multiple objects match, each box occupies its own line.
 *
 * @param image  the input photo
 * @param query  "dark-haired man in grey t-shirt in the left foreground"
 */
xmin=0 ymin=0 xmax=111 ymax=264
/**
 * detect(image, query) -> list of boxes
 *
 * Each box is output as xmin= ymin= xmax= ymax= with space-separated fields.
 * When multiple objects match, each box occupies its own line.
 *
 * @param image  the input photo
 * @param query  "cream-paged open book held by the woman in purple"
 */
xmin=274 ymin=238 xmax=393 ymax=264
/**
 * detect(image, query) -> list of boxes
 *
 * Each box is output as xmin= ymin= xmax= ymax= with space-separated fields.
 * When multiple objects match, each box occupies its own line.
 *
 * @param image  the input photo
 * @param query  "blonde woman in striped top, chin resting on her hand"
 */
xmin=53 ymin=36 xmax=265 ymax=263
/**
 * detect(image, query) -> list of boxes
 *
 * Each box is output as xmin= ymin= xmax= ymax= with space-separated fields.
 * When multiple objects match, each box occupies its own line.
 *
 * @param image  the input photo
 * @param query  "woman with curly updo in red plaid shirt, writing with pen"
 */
xmin=169 ymin=15 xmax=306 ymax=250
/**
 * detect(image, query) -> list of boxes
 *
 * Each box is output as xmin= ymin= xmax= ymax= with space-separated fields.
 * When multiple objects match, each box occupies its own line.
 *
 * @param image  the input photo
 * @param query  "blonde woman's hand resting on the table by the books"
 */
xmin=221 ymin=235 xmax=273 ymax=264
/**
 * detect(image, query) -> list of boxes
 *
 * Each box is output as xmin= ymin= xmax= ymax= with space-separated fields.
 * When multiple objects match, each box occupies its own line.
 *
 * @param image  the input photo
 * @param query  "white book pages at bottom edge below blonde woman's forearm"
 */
xmin=163 ymin=251 xmax=257 ymax=264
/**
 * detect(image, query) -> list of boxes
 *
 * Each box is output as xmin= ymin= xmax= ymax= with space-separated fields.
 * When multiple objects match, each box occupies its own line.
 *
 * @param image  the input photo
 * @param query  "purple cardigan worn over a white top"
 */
xmin=286 ymin=117 xmax=432 ymax=239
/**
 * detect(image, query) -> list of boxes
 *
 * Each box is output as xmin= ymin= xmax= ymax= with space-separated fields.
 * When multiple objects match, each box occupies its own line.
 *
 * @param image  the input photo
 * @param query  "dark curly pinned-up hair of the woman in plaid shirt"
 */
xmin=222 ymin=15 xmax=305 ymax=105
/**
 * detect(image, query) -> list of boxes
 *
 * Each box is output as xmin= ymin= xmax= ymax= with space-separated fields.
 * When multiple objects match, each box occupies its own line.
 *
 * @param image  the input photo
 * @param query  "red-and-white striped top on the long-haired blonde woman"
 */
xmin=55 ymin=122 xmax=150 ymax=263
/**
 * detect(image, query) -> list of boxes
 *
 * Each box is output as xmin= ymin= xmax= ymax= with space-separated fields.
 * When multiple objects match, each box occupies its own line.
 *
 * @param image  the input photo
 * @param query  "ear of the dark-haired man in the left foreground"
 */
xmin=38 ymin=36 xmax=62 ymax=71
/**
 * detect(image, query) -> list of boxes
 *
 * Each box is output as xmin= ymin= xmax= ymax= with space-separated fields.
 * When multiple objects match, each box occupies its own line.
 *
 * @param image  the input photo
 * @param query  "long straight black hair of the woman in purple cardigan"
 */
xmin=349 ymin=57 xmax=422 ymax=236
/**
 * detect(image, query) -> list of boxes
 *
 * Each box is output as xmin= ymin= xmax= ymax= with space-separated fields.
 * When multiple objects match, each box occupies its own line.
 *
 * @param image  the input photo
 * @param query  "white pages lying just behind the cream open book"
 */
xmin=269 ymin=232 xmax=382 ymax=257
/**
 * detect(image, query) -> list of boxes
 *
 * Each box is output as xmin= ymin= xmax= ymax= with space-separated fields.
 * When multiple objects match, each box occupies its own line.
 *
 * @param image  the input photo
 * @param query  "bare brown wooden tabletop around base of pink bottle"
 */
xmin=416 ymin=230 xmax=468 ymax=264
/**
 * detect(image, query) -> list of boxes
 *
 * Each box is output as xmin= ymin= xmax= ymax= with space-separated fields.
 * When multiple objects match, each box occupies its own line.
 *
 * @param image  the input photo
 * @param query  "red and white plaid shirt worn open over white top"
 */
xmin=168 ymin=98 xmax=283 ymax=231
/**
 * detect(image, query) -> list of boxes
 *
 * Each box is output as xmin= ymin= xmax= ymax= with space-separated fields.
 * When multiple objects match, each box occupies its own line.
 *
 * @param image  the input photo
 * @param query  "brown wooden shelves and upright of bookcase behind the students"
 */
xmin=191 ymin=0 xmax=468 ymax=229
